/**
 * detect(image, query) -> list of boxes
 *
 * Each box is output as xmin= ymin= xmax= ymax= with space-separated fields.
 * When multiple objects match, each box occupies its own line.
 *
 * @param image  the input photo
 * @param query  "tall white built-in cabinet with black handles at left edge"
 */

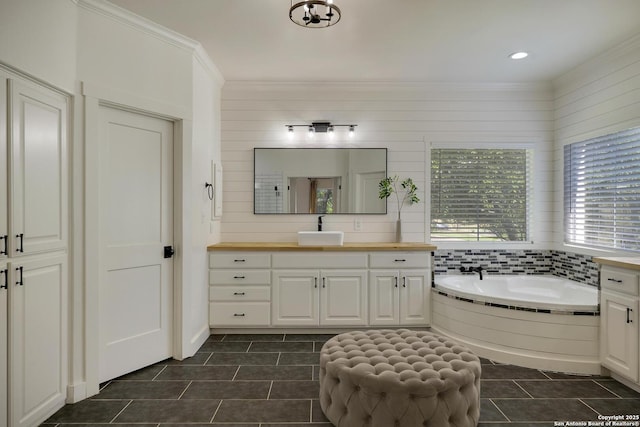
xmin=0 ymin=70 xmax=68 ymax=427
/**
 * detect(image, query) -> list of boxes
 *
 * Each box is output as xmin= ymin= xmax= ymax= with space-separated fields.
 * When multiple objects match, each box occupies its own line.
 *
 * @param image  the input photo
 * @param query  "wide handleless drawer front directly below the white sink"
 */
xmin=273 ymin=252 xmax=367 ymax=269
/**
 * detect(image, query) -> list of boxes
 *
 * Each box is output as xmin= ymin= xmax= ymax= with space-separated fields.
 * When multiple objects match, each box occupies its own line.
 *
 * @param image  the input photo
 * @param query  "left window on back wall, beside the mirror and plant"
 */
xmin=431 ymin=148 xmax=531 ymax=242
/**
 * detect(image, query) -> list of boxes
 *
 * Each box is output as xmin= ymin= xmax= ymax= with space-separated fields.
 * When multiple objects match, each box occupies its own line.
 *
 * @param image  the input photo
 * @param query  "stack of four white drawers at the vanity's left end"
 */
xmin=209 ymin=252 xmax=271 ymax=327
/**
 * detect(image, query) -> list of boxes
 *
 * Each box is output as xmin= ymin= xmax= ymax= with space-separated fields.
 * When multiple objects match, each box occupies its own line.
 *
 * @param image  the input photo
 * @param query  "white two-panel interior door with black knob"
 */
xmin=99 ymin=106 xmax=173 ymax=382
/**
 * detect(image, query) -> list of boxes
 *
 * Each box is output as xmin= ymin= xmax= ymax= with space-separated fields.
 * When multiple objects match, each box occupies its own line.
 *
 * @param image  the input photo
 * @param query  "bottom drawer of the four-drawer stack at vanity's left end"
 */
xmin=209 ymin=302 xmax=271 ymax=328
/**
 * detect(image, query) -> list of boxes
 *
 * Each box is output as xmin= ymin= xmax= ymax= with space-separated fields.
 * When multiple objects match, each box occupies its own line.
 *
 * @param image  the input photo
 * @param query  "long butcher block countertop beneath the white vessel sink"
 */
xmin=207 ymin=242 xmax=436 ymax=252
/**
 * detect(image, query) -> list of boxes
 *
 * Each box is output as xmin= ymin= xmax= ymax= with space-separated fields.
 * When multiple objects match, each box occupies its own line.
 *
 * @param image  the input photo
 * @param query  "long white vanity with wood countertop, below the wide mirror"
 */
xmin=209 ymin=243 xmax=435 ymax=329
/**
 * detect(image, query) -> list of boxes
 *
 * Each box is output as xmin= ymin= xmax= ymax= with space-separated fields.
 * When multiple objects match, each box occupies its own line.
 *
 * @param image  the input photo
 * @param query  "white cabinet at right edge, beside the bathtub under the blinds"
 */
xmin=600 ymin=265 xmax=640 ymax=383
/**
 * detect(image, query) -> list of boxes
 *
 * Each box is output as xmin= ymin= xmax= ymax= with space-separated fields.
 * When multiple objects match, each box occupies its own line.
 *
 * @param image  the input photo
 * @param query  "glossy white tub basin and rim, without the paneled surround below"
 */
xmin=435 ymin=275 xmax=598 ymax=313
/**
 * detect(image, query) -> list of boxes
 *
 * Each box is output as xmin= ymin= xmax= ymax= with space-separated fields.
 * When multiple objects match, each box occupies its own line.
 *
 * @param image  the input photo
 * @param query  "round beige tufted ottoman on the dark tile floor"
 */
xmin=320 ymin=329 xmax=480 ymax=427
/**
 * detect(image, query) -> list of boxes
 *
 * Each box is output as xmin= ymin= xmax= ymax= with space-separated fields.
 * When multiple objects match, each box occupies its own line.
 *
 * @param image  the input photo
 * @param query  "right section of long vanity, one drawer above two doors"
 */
xmin=369 ymin=252 xmax=431 ymax=326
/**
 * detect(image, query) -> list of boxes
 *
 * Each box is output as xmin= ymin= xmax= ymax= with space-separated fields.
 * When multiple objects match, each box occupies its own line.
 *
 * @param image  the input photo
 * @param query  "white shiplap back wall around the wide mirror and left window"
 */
xmin=221 ymin=82 xmax=553 ymax=248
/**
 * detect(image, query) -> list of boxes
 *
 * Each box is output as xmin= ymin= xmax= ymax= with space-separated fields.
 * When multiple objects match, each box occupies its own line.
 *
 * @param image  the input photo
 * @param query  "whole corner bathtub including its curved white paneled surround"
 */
xmin=431 ymin=274 xmax=602 ymax=374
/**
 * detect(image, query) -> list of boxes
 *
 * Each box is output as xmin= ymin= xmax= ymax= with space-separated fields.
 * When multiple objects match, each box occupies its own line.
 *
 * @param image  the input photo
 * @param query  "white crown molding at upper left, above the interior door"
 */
xmin=71 ymin=0 xmax=224 ymax=85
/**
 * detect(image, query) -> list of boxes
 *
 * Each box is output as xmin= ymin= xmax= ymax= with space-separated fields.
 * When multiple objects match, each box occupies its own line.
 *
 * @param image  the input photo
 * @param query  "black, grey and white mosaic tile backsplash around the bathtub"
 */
xmin=433 ymin=249 xmax=599 ymax=287
